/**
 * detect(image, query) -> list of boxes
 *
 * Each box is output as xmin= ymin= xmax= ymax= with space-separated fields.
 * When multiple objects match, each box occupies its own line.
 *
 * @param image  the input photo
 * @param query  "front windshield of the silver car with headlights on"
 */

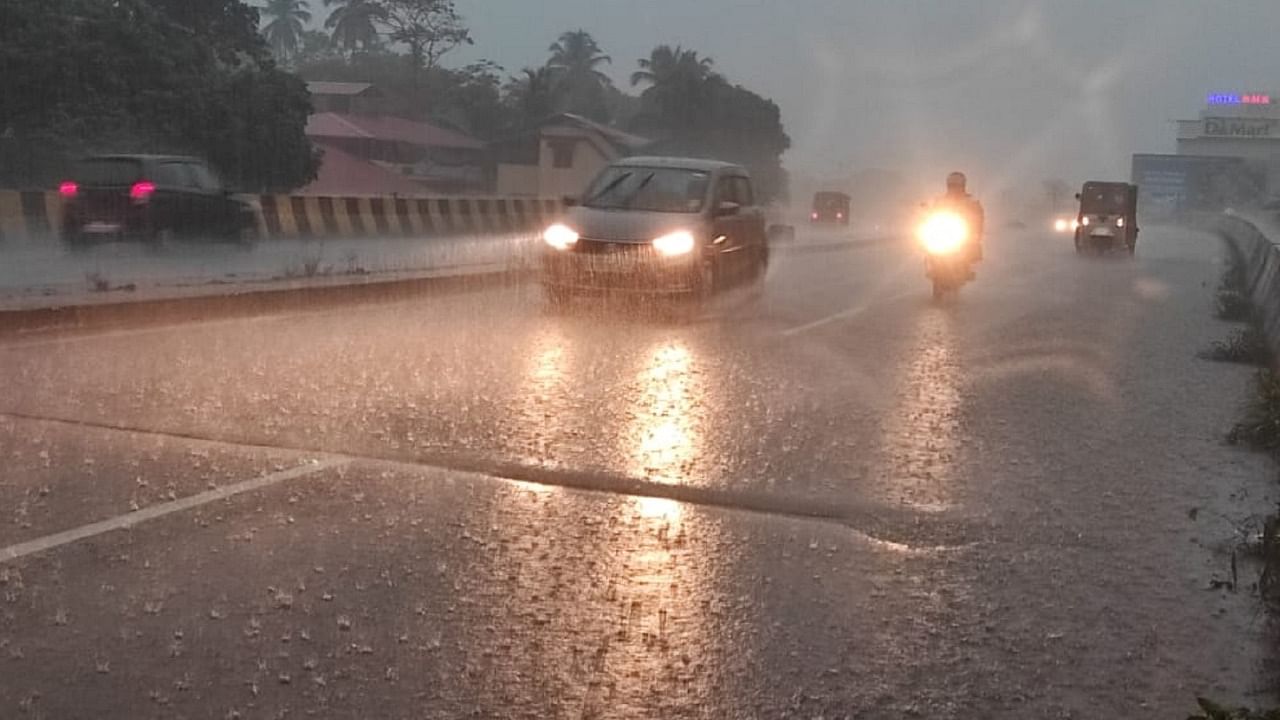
xmin=582 ymin=165 xmax=710 ymax=213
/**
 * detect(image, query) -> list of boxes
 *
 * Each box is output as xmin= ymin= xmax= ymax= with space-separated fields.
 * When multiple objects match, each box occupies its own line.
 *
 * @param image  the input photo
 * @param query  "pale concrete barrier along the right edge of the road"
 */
xmin=1213 ymin=213 xmax=1280 ymax=357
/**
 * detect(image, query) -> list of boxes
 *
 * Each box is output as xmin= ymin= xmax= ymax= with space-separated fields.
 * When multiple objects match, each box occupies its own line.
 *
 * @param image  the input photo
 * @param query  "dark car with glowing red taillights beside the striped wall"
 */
xmin=58 ymin=155 xmax=257 ymax=246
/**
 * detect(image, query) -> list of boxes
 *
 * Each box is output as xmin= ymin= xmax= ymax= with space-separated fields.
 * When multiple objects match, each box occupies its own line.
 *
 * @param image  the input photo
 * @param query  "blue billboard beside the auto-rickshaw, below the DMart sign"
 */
xmin=1132 ymin=155 xmax=1266 ymax=217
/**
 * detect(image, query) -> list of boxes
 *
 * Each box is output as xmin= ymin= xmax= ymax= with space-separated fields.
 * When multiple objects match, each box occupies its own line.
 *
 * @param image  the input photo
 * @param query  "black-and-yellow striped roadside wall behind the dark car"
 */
xmin=0 ymin=190 xmax=563 ymax=241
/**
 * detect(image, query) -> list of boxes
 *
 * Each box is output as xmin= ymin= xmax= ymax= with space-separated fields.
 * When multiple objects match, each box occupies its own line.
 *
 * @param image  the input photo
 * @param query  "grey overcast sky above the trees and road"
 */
xmin=437 ymin=0 xmax=1280 ymax=193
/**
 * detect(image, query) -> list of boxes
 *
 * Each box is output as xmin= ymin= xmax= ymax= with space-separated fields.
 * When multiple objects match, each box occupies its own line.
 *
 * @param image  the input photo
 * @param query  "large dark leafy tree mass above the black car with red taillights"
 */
xmin=0 ymin=0 xmax=316 ymax=191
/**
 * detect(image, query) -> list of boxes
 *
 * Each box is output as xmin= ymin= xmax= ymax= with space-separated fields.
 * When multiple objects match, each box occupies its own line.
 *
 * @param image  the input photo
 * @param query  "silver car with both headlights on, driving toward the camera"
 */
xmin=543 ymin=158 xmax=769 ymax=302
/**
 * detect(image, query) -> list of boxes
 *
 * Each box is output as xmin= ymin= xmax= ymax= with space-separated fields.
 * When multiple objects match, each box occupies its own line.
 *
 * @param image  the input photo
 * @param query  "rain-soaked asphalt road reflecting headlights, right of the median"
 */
xmin=0 ymin=221 xmax=1277 ymax=719
